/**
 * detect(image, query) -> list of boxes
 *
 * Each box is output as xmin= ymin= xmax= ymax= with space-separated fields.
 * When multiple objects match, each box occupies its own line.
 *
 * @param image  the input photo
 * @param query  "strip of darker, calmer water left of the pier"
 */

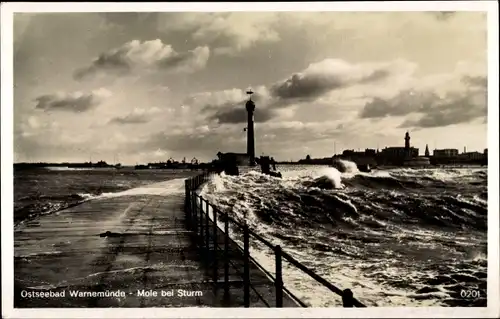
xmin=14 ymin=167 xmax=199 ymax=223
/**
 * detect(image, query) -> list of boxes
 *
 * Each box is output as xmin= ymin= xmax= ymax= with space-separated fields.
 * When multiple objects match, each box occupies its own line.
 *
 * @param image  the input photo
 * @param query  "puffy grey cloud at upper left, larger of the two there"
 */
xmin=73 ymin=39 xmax=210 ymax=80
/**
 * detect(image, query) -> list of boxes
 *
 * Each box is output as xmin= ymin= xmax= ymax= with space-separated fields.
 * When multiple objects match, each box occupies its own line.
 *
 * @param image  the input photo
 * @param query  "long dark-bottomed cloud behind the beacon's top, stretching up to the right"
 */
xmin=189 ymin=59 xmax=414 ymax=124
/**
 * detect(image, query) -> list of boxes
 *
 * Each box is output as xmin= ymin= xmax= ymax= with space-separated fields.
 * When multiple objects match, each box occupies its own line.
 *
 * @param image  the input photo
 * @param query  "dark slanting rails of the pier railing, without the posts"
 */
xmin=186 ymin=172 xmax=366 ymax=307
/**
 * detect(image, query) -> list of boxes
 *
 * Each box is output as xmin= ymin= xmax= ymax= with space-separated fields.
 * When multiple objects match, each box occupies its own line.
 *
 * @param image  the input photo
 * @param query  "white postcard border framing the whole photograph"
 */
xmin=1 ymin=1 xmax=500 ymax=318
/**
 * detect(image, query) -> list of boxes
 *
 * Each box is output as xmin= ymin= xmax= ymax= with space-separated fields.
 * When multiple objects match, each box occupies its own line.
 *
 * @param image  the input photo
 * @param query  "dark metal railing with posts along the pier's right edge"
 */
xmin=185 ymin=172 xmax=366 ymax=308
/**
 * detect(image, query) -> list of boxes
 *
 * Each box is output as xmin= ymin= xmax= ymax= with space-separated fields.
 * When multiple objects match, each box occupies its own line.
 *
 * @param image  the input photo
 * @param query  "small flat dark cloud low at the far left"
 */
xmin=35 ymin=89 xmax=110 ymax=112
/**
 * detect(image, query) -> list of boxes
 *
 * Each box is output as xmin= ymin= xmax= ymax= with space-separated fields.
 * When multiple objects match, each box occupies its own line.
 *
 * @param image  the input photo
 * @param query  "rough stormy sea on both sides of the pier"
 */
xmin=14 ymin=161 xmax=488 ymax=307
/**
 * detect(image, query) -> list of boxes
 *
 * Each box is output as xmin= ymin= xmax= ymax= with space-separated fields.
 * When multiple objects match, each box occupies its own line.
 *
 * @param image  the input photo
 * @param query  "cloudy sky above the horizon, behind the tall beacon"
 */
xmin=13 ymin=12 xmax=488 ymax=164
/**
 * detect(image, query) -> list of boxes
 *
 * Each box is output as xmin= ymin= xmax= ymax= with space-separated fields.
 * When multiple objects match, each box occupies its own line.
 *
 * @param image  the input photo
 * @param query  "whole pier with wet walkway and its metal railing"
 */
xmin=14 ymin=173 xmax=363 ymax=308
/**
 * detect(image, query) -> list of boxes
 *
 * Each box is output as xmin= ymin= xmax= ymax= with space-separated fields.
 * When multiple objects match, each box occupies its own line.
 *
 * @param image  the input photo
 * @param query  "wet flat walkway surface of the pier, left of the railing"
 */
xmin=14 ymin=180 xmax=296 ymax=308
